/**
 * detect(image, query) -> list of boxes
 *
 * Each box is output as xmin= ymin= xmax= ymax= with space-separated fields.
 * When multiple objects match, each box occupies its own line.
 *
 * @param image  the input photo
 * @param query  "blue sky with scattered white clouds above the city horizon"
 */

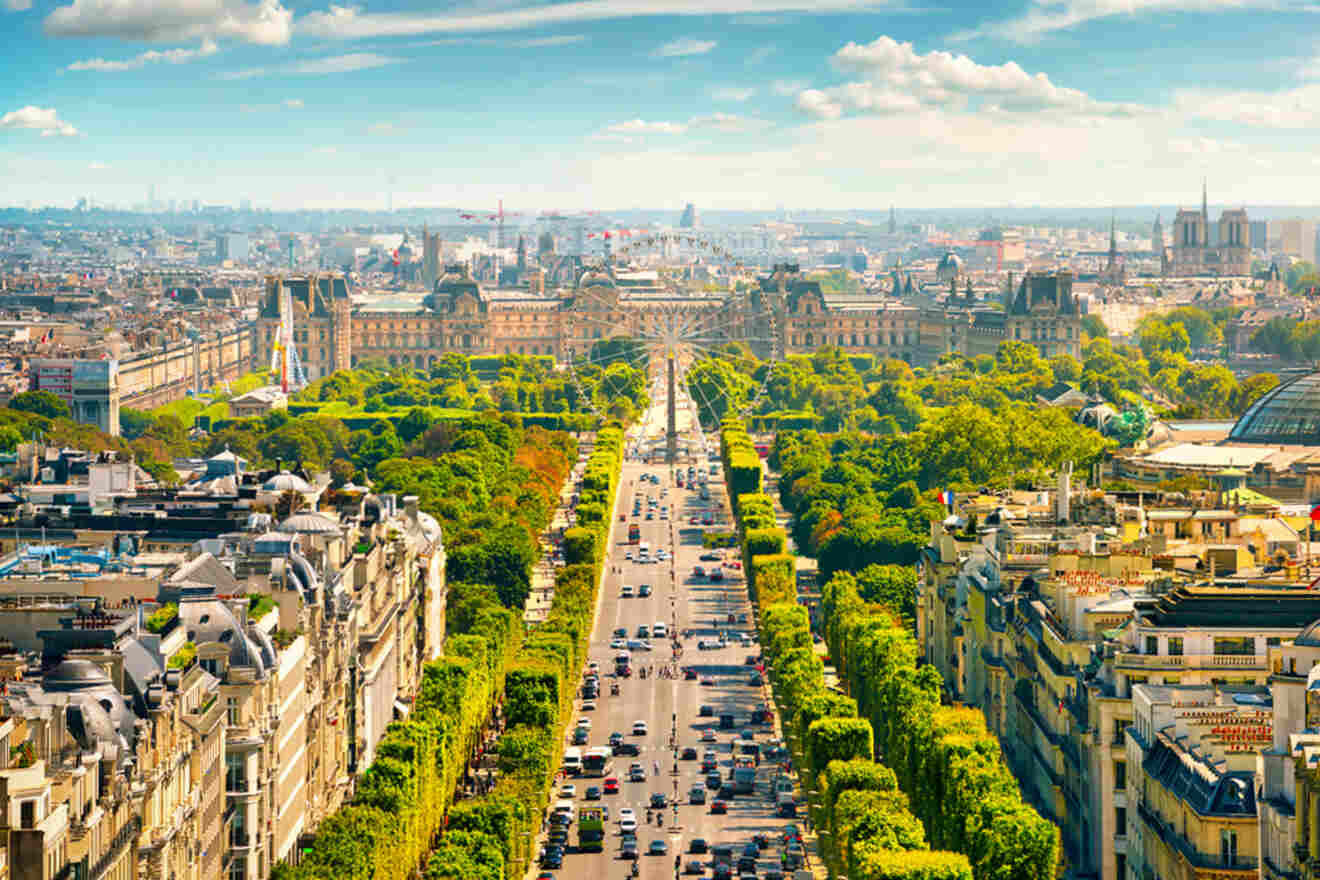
xmin=0 ymin=0 xmax=1320 ymax=211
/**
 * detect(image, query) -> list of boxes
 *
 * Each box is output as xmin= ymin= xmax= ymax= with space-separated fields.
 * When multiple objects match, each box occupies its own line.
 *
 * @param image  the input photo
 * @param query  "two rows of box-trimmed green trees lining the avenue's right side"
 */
xmin=721 ymin=421 xmax=1059 ymax=880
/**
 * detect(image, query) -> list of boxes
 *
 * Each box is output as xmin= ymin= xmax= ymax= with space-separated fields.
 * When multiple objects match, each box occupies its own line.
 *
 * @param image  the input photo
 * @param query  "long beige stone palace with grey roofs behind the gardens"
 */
xmin=256 ymin=264 xmax=1082 ymax=380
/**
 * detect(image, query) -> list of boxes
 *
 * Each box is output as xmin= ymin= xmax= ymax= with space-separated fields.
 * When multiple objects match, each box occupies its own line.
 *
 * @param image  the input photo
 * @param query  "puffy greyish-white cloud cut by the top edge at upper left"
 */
xmin=45 ymin=0 xmax=293 ymax=46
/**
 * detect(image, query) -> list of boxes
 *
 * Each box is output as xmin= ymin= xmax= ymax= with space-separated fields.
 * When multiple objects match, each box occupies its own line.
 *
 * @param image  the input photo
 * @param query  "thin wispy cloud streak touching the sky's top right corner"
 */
xmin=950 ymin=0 xmax=1317 ymax=44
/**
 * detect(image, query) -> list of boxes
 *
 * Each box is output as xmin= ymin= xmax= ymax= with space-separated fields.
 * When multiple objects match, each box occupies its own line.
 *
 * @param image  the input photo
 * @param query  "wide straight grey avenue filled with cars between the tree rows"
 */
xmin=533 ymin=394 xmax=793 ymax=880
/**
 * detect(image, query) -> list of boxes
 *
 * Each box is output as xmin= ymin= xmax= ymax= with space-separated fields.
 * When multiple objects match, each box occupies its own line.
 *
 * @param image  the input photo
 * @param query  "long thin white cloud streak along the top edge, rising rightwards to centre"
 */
xmin=299 ymin=0 xmax=895 ymax=40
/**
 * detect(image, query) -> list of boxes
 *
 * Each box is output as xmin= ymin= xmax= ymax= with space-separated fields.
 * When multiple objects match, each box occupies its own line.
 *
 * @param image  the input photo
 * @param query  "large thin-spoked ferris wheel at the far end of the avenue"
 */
xmin=566 ymin=231 xmax=781 ymax=427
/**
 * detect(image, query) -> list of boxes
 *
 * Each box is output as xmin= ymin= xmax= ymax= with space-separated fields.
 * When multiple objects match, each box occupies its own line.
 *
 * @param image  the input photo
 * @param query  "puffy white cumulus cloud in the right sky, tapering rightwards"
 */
xmin=797 ymin=36 xmax=1147 ymax=119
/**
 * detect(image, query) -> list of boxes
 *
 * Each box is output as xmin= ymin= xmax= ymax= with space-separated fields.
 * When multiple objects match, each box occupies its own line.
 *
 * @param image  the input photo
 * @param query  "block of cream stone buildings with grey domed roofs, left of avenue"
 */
xmin=0 ymin=489 xmax=445 ymax=880
